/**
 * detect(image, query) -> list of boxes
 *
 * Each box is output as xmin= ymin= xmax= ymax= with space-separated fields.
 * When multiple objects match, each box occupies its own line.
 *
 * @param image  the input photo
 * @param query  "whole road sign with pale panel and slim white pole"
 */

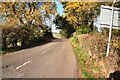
xmin=100 ymin=1 xmax=120 ymax=57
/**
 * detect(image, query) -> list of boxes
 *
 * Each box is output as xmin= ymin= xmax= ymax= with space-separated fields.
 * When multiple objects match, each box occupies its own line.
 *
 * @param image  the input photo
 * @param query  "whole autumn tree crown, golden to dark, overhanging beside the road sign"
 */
xmin=62 ymin=2 xmax=115 ymax=31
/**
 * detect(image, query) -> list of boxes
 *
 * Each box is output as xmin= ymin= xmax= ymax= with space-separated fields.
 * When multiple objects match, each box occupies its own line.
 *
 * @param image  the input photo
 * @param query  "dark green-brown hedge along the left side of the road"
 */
xmin=2 ymin=26 xmax=49 ymax=50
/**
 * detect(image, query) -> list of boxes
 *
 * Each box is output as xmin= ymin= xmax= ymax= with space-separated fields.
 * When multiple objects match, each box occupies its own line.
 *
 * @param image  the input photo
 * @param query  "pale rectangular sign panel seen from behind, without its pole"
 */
xmin=100 ymin=5 xmax=120 ymax=29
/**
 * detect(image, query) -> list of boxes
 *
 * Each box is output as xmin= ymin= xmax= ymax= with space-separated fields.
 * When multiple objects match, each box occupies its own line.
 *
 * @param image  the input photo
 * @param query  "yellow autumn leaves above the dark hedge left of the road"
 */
xmin=0 ymin=2 xmax=56 ymax=29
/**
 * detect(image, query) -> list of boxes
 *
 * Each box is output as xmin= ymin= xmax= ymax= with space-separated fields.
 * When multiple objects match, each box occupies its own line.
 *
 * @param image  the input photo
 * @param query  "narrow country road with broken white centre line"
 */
xmin=2 ymin=39 xmax=77 ymax=78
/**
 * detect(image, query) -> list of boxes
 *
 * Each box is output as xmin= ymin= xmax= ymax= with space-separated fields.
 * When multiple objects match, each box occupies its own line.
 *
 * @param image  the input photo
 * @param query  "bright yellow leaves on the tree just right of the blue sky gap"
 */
xmin=64 ymin=2 xmax=98 ymax=23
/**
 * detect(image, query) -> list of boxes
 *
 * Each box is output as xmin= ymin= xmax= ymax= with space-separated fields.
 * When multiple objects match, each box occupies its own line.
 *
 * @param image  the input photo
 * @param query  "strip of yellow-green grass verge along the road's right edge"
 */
xmin=70 ymin=37 xmax=104 ymax=80
